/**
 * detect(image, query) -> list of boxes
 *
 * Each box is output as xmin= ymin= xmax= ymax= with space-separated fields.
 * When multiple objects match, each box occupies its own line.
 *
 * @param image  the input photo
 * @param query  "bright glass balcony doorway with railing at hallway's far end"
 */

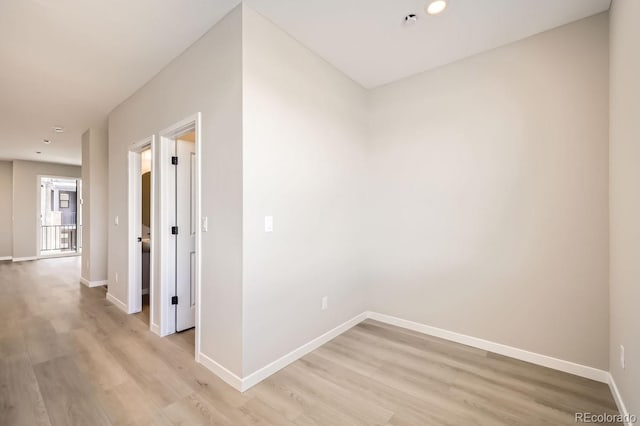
xmin=38 ymin=176 xmax=82 ymax=257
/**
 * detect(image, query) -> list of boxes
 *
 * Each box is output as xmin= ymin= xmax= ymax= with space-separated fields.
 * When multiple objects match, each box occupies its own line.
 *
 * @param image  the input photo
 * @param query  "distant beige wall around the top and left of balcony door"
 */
xmin=13 ymin=160 xmax=81 ymax=260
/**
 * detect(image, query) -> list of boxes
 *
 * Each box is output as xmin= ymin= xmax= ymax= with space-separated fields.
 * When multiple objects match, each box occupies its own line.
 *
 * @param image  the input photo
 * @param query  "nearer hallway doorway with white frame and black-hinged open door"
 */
xmin=158 ymin=114 xmax=200 ymax=350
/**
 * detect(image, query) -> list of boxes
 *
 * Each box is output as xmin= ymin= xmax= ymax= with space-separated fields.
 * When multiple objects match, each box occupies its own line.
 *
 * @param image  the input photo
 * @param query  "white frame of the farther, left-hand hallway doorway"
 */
xmin=127 ymin=135 xmax=155 ymax=334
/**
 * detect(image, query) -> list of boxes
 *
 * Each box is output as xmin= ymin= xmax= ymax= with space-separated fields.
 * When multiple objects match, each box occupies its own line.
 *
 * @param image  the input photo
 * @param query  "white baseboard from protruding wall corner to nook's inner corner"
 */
xmin=242 ymin=312 xmax=367 ymax=392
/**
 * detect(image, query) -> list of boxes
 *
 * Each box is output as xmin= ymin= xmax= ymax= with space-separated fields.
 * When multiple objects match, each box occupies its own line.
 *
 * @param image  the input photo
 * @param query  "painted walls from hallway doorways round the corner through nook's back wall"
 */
xmin=107 ymin=6 xmax=609 ymax=386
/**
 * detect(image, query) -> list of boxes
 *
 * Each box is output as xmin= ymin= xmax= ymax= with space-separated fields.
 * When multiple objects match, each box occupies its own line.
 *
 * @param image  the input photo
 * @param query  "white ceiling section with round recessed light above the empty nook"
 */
xmin=247 ymin=0 xmax=610 ymax=88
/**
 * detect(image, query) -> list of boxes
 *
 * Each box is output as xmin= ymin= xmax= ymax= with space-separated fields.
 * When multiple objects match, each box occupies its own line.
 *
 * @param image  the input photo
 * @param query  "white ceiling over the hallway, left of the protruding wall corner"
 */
xmin=0 ymin=0 xmax=238 ymax=164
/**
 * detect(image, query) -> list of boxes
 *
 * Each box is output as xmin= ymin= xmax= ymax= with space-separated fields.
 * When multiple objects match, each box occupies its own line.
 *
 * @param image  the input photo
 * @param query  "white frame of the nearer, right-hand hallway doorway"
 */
xmin=156 ymin=112 xmax=202 ymax=352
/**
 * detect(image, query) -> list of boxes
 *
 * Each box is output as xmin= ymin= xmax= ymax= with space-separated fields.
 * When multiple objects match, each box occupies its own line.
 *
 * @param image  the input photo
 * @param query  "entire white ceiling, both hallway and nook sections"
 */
xmin=0 ymin=0 xmax=610 ymax=164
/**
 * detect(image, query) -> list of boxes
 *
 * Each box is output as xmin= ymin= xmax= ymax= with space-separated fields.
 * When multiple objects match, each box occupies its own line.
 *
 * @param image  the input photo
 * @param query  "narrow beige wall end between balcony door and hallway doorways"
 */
xmin=81 ymin=128 xmax=109 ymax=282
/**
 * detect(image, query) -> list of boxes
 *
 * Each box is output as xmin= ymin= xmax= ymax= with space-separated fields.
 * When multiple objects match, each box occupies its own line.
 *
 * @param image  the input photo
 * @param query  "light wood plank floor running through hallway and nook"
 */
xmin=0 ymin=258 xmax=617 ymax=426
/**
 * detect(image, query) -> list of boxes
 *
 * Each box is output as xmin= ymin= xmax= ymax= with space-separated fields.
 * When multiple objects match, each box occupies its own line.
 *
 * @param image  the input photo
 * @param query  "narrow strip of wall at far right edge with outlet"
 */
xmin=609 ymin=0 xmax=640 ymax=415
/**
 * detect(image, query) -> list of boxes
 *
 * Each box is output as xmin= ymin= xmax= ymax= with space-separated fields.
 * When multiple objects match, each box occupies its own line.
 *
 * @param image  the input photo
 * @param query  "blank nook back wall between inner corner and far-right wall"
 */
xmin=367 ymin=14 xmax=608 ymax=369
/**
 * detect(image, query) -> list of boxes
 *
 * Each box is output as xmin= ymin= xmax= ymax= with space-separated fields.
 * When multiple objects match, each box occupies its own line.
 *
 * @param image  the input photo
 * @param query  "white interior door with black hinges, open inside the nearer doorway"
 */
xmin=175 ymin=139 xmax=197 ymax=331
